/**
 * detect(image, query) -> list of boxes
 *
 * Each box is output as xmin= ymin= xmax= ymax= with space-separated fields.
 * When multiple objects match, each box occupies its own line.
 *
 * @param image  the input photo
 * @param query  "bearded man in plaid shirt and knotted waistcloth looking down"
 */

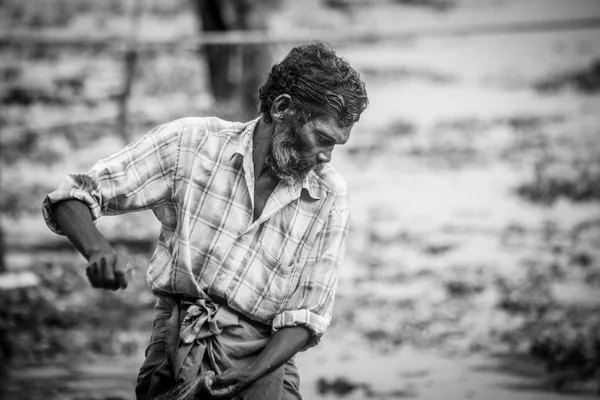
xmin=43 ymin=43 xmax=368 ymax=400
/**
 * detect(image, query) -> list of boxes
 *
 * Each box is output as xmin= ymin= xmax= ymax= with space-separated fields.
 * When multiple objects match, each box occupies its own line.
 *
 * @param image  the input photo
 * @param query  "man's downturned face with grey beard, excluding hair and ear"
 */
xmin=269 ymin=115 xmax=352 ymax=184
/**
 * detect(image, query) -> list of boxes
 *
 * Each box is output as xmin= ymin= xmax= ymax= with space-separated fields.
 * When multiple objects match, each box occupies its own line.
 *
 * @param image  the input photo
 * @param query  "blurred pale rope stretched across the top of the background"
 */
xmin=0 ymin=16 xmax=600 ymax=53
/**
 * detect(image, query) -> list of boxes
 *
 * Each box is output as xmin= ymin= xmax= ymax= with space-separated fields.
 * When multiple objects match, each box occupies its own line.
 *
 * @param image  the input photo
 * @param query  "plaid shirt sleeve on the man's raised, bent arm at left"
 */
xmin=42 ymin=121 xmax=181 ymax=235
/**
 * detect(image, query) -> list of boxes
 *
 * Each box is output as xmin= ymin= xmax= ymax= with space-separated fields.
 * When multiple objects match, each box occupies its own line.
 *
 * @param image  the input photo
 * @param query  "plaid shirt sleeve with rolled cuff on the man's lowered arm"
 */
xmin=272 ymin=196 xmax=350 ymax=350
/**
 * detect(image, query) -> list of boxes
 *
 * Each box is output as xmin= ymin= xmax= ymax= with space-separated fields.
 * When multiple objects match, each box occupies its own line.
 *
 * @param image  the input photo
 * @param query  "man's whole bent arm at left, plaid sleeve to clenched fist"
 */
xmin=42 ymin=121 xmax=181 ymax=290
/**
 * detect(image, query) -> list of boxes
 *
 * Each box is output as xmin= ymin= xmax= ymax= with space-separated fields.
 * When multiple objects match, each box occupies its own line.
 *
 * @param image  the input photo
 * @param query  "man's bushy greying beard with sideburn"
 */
xmin=265 ymin=120 xmax=323 ymax=185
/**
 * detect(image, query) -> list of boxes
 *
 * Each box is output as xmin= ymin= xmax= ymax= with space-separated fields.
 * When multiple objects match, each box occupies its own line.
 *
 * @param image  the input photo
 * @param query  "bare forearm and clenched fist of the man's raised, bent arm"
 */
xmin=53 ymin=200 xmax=128 ymax=290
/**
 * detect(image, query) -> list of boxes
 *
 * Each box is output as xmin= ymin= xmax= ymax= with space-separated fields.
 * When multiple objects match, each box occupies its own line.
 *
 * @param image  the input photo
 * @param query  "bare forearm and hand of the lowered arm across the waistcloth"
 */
xmin=202 ymin=325 xmax=311 ymax=400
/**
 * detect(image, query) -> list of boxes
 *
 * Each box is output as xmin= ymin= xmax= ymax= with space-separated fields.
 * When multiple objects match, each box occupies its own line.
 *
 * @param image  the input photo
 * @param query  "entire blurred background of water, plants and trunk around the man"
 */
xmin=0 ymin=0 xmax=600 ymax=400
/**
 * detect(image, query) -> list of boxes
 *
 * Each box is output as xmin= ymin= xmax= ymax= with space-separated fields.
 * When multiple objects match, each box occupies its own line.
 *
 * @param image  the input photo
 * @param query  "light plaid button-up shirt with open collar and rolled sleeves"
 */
xmin=43 ymin=118 xmax=350 ymax=347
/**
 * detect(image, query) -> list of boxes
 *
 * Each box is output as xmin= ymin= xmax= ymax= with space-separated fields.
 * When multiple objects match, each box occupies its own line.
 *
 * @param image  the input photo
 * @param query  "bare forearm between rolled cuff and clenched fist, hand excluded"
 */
xmin=53 ymin=200 xmax=112 ymax=261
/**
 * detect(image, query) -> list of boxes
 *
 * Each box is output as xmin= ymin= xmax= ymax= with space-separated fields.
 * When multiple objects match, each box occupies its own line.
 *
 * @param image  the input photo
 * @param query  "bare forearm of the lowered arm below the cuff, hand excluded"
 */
xmin=246 ymin=325 xmax=311 ymax=380
